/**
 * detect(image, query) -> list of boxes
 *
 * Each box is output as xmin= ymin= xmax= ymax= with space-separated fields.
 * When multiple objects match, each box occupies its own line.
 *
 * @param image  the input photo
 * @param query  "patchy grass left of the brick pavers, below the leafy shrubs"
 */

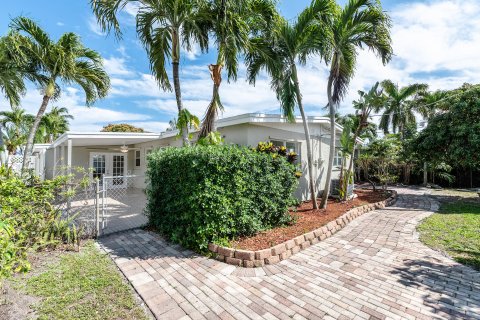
xmin=20 ymin=242 xmax=147 ymax=319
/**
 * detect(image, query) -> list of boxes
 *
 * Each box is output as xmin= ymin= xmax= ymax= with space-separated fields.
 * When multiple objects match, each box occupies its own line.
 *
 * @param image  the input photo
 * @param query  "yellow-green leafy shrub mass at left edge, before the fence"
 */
xmin=0 ymin=166 xmax=79 ymax=280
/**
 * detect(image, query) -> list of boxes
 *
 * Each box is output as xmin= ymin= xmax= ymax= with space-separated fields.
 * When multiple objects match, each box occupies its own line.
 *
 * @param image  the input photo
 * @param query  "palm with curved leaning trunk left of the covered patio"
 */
xmin=6 ymin=17 xmax=110 ymax=172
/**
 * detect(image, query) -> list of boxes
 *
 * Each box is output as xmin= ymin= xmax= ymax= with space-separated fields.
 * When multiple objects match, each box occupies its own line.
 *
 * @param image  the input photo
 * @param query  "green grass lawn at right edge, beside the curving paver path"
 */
xmin=417 ymin=201 xmax=480 ymax=270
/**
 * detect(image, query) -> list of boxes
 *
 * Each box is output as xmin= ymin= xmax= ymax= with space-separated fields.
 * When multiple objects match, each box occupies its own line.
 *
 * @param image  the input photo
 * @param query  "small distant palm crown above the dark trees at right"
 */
xmin=379 ymin=80 xmax=428 ymax=138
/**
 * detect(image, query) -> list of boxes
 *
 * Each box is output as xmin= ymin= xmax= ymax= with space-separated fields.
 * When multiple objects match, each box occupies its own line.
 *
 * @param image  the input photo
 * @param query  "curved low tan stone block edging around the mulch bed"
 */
xmin=208 ymin=190 xmax=397 ymax=268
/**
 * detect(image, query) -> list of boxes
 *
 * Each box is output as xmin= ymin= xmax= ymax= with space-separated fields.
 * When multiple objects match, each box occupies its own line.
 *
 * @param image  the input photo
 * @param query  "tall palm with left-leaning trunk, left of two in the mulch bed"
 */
xmin=245 ymin=0 xmax=334 ymax=209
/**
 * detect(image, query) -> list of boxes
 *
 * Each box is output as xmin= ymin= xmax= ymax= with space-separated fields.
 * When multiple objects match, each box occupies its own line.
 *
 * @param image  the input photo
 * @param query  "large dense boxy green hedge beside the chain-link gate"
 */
xmin=147 ymin=146 xmax=298 ymax=250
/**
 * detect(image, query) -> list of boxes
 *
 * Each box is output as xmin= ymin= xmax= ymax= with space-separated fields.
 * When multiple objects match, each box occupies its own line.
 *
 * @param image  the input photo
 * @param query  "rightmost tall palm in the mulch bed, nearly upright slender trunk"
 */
xmin=321 ymin=0 xmax=392 ymax=208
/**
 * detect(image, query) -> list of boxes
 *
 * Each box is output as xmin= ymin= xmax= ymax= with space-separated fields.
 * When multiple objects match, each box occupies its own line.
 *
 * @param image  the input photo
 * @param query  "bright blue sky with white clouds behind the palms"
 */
xmin=0 ymin=0 xmax=480 ymax=131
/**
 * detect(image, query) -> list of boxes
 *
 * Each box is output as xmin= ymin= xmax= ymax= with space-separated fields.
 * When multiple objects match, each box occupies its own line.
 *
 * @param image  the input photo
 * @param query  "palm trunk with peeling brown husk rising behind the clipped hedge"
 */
xmin=199 ymin=64 xmax=223 ymax=138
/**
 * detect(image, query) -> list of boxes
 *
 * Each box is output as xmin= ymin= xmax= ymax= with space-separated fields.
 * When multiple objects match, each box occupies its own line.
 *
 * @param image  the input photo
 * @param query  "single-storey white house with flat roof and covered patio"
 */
xmin=39 ymin=113 xmax=356 ymax=200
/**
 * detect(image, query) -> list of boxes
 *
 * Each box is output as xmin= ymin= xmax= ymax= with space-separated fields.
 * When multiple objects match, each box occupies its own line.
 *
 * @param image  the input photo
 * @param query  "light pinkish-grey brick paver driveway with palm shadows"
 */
xmin=101 ymin=189 xmax=480 ymax=319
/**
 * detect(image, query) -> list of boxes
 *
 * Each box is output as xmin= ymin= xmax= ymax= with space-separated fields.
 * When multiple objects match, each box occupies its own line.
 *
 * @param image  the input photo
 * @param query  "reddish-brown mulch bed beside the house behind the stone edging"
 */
xmin=231 ymin=190 xmax=388 ymax=251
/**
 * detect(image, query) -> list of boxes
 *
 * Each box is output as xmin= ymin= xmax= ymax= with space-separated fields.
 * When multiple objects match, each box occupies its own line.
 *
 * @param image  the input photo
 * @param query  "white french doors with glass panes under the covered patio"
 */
xmin=90 ymin=152 xmax=127 ymax=188
